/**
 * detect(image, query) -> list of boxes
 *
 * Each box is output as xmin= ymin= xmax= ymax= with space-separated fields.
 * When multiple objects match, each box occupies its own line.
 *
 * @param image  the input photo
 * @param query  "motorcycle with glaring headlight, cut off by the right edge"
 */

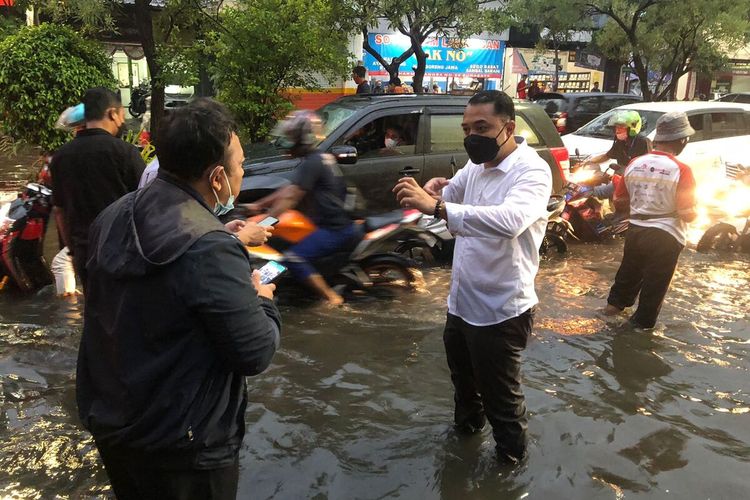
xmin=696 ymin=166 xmax=750 ymax=253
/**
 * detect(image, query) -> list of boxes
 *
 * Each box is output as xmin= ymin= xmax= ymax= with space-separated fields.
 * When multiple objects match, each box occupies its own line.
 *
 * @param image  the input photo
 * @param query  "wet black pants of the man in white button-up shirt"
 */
xmin=443 ymin=310 xmax=534 ymax=459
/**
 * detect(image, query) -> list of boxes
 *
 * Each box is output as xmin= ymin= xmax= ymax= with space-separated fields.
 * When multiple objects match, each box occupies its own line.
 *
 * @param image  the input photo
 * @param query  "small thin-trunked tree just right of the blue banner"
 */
xmin=506 ymin=0 xmax=593 ymax=90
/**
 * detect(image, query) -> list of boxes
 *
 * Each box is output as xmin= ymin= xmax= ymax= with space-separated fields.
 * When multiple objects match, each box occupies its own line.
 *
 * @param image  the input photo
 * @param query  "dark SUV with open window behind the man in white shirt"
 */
xmin=238 ymin=94 xmax=568 ymax=213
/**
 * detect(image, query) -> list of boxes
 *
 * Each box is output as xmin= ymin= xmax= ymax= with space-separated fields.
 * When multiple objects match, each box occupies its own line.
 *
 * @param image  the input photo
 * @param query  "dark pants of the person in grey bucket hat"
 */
xmin=607 ymin=224 xmax=684 ymax=328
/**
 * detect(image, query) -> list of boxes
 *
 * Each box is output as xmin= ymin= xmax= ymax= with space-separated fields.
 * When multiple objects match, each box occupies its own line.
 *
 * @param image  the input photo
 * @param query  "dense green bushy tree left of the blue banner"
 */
xmin=207 ymin=0 xmax=351 ymax=141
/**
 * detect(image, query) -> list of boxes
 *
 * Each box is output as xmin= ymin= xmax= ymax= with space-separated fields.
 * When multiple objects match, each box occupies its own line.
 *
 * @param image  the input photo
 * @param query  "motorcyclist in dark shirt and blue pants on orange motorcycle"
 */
xmin=248 ymin=111 xmax=355 ymax=305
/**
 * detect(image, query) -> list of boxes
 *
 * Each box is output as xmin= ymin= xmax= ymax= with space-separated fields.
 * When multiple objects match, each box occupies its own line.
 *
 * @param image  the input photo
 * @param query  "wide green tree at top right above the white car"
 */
xmin=588 ymin=0 xmax=750 ymax=101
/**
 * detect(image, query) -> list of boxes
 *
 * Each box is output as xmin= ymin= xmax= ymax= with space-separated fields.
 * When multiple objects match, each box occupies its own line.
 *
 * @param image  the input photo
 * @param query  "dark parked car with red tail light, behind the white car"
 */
xmin=534 ymin=92 xmax=643 ymax=135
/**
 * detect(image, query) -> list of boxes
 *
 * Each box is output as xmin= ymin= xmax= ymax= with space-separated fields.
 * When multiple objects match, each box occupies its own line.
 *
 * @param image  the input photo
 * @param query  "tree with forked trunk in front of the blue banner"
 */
xmin=352 ymin=0 xmax=497 ymax=93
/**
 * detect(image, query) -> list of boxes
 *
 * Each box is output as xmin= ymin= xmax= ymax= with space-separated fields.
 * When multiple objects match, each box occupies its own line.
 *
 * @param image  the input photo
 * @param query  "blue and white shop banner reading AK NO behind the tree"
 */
xmin=363 ymin=33 xmax=505 ymax=92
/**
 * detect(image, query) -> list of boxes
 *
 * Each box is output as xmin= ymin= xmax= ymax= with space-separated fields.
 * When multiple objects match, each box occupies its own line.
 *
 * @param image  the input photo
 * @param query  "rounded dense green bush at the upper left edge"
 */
xmin=0 ymin=24 xmax=114 ymax=151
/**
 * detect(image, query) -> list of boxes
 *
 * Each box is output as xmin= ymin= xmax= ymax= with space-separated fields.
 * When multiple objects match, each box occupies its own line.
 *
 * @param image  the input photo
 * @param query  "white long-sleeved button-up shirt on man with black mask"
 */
xmin=442 ymin=137 xmax=552 ymax=326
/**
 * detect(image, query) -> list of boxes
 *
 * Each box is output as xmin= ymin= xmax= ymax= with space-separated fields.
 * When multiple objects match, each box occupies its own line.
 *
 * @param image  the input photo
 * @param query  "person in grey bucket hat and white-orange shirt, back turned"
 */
xmin=604 ymin=111 xmax=696 ymax=328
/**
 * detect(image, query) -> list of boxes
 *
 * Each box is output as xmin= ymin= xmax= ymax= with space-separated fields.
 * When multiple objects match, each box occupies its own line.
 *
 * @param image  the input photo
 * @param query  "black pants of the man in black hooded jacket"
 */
xmin=99 ymin=447 xmax=239 ymax=500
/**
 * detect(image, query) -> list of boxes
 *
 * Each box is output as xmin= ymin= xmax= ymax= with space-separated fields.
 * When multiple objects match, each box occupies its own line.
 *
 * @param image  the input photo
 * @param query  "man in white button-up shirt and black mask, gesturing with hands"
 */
xmin=394 ymin=90 xmax=552 ymax=463
